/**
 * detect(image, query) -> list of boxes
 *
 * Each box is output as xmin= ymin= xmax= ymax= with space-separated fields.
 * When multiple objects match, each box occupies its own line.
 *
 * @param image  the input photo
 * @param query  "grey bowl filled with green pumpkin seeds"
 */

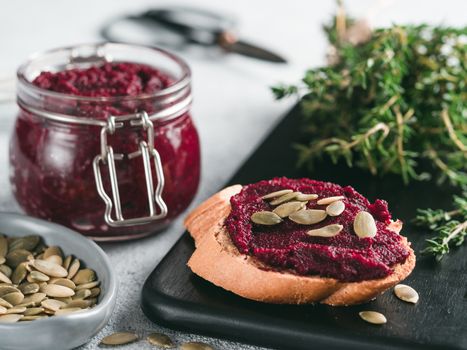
xmin=0 ymin=213 xmax=117 ymax=350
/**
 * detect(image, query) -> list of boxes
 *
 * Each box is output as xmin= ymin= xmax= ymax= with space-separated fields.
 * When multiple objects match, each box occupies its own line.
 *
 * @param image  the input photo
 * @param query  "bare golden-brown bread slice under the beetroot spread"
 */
xmin=185 ymin=185 xmax=415 ymax=306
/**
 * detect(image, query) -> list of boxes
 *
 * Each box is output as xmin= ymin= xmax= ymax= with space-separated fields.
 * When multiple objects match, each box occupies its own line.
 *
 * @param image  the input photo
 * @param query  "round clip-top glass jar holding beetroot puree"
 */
xmin=10 ymin=43 xmax=200 ymax=241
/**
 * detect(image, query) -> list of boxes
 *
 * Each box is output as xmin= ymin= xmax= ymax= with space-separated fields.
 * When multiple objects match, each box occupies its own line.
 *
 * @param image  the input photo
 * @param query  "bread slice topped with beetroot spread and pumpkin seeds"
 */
xmin=185 ymin=178 xmax=415 ymax=305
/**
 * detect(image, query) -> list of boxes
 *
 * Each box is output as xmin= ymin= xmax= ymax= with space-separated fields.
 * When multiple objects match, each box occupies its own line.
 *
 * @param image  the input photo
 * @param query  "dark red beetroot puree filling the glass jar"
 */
xmin=10 ymin=62 xmax=200 ymax=237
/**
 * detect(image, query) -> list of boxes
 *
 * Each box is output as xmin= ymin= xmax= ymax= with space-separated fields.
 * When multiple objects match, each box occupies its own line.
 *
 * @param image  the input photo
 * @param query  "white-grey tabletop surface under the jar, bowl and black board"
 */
xmin=0 ymin=0 xmax=467 ymax=349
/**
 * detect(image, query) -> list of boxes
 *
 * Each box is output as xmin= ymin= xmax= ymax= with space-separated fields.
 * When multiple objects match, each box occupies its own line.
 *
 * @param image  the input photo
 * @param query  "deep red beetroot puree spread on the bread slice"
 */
xmin=226 ymin=178 xmax=409 ymax=281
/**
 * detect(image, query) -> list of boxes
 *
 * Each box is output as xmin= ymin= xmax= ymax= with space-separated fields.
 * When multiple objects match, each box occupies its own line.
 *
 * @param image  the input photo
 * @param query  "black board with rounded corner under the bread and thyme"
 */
xmin=142 ymin=108 xmax=467 ymax=350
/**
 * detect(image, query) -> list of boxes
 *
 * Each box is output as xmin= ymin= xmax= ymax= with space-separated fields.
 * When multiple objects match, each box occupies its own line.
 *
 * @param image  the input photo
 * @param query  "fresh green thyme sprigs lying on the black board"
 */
xmin=272 ymin=7 xmax=467 ymax=256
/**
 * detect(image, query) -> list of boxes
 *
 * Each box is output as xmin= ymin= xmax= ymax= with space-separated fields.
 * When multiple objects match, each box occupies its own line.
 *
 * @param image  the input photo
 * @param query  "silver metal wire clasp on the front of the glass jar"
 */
xmin=93 ymin=112 xmax=167 ymax=227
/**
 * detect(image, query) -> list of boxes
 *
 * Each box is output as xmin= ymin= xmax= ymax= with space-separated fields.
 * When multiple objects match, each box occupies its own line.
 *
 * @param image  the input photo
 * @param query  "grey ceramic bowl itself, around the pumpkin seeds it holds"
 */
xmin=0 ymin=213 xmax=117 ymax=350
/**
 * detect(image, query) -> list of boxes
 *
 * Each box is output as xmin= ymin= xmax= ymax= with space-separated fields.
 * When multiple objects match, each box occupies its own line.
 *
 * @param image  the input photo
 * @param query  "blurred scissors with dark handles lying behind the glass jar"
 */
xmin=101 ymin=6 xmax=287 ymax=63
